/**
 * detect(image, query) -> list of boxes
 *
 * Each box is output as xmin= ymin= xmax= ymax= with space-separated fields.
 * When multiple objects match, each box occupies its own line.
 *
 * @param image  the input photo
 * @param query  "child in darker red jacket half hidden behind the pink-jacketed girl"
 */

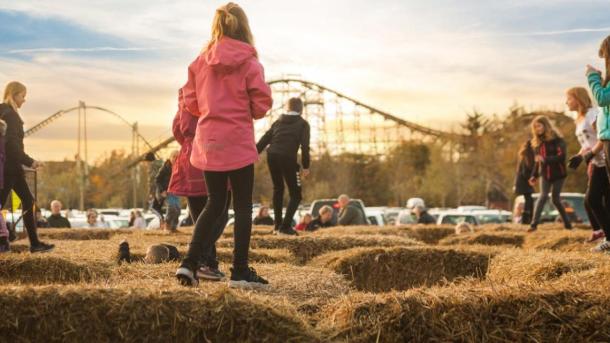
xmin=169 ymin=89 xmax=231 ymax=281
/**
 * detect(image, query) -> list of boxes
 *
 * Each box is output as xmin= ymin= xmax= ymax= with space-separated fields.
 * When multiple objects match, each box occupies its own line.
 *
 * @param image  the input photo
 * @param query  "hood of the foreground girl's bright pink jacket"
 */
xmin=204 ymin=37 xmax=256 ymax=72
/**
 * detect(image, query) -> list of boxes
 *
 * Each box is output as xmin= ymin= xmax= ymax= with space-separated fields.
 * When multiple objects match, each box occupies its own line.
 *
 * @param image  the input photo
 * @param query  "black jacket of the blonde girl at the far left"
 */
xmin=0 ymin=104 xmax=34 ymax=175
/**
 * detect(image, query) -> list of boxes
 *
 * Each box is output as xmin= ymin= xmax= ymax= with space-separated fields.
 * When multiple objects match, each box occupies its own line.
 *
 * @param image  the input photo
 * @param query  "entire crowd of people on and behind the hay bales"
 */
xmin=0 ymin=3 xmax=610 ymax=287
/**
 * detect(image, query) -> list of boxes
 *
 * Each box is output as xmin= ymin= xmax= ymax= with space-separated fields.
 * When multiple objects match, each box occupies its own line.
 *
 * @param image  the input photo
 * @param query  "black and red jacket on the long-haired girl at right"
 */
xmin=532 ymin=137 xmax=568 ymax=182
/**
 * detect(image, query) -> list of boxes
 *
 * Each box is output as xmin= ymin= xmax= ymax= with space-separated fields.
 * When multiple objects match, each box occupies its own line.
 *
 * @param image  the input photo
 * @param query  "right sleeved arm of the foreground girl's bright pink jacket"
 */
xmin=246 ymin=59 xmax=273 ymax=119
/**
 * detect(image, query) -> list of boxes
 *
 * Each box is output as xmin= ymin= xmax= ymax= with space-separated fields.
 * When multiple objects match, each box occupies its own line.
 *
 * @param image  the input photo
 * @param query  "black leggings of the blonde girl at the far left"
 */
xmin=0 ymin=173 xmax=40 ymax=246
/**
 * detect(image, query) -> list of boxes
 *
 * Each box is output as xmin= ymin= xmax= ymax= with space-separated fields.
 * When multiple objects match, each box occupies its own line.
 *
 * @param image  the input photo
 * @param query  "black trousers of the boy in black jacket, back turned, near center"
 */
xmin=267 ymin=154 xmax=302 ymax=230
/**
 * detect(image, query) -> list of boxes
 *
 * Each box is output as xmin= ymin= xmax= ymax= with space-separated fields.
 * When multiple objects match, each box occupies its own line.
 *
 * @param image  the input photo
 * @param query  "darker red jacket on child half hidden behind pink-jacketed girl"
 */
xmin=168 ymin=89 xmax=208 ymax=197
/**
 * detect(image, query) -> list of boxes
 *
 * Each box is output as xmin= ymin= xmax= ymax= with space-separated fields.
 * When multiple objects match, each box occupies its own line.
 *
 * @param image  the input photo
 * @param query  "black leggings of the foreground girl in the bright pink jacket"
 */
xmin=182 ymin=164 xmax=254 ymax=271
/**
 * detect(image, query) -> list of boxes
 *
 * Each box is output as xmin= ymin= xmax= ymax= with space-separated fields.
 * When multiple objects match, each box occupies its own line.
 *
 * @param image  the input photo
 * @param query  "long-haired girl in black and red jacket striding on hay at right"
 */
xmin=528 ymin=116 xmax=572 ymax=232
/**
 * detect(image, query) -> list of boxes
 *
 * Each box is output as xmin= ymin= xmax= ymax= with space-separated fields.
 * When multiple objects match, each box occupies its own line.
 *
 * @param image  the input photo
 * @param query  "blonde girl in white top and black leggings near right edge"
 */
xmin=566 ymin=87 xmax=610 ymax=248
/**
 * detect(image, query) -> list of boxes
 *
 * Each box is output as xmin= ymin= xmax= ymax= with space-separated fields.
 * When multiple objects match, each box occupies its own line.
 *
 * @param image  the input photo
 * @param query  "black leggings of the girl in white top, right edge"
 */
xmin=585 ymin=166 xmax=610 ymax=237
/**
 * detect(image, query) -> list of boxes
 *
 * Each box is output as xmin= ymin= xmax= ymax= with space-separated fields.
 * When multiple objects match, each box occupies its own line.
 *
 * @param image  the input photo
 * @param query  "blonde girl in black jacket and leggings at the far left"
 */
xmin=0 ymin=82 xmax=55 ymax=253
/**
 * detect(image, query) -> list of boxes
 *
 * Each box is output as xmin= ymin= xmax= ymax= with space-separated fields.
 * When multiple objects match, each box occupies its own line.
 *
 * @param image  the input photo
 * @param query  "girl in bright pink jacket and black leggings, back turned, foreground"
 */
xmin=176 ymin=3 xmax=273 ymax=287
